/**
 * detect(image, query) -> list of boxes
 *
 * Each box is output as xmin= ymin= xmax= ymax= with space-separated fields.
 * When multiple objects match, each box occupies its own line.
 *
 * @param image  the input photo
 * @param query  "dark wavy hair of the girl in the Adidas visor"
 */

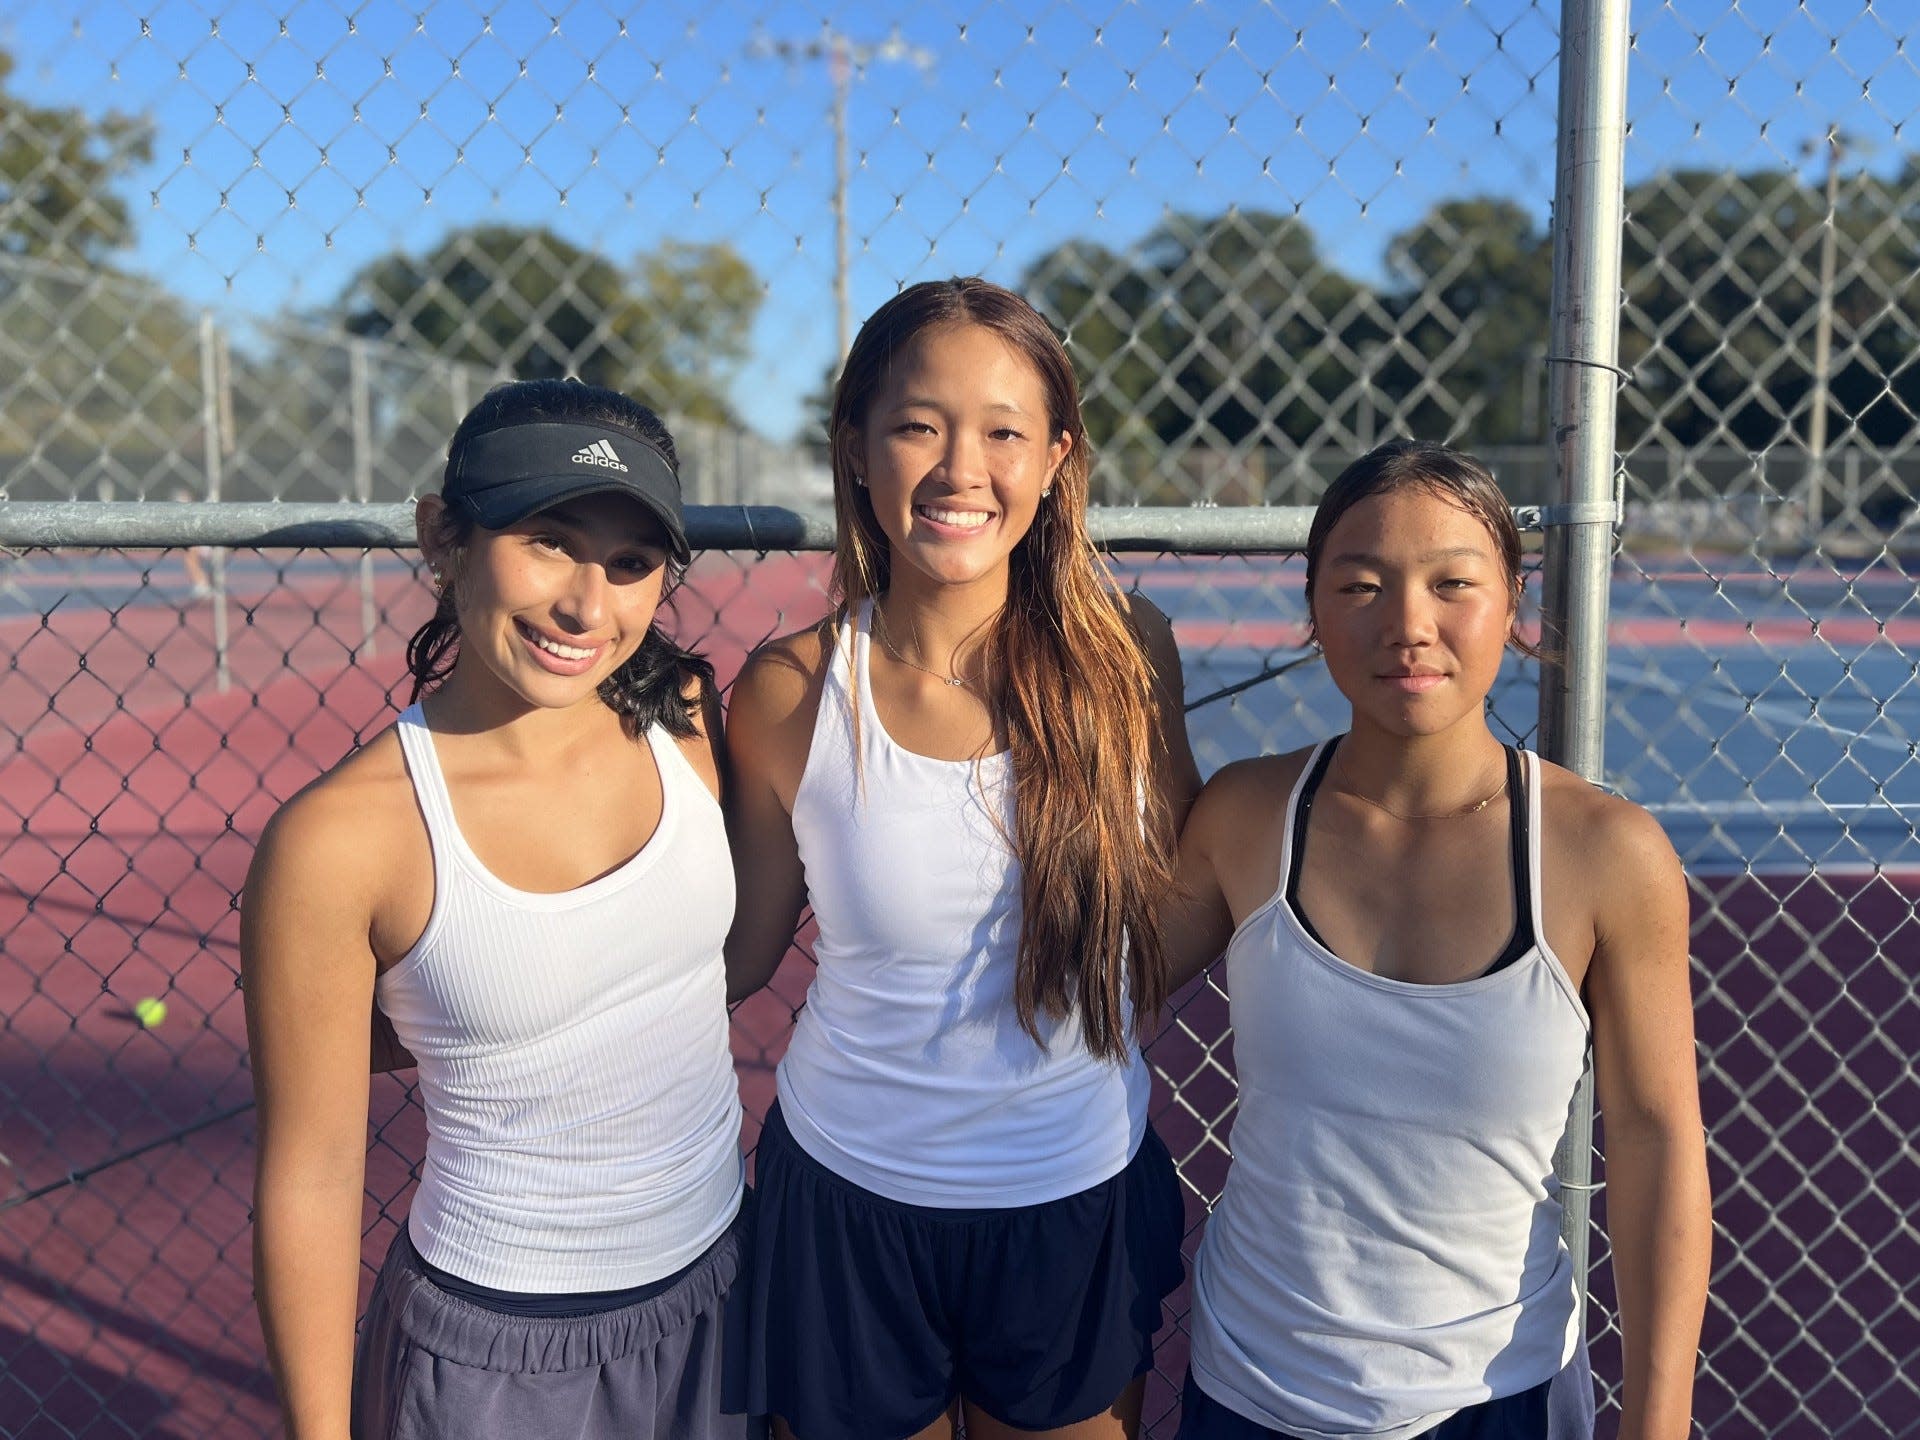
xmin=407 ymin=380 xmax=716 ymax=739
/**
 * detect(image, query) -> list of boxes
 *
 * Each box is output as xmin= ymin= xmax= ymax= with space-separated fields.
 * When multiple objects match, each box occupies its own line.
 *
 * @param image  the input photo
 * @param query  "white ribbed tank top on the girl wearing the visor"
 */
xmin=374 ymin=705 xmax=743 ymax=1294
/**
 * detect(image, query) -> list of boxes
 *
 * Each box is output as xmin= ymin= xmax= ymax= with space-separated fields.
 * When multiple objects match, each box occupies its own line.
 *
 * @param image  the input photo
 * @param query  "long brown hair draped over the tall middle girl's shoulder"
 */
xmin=831 ymin=278 xmax=1173 ymax=1060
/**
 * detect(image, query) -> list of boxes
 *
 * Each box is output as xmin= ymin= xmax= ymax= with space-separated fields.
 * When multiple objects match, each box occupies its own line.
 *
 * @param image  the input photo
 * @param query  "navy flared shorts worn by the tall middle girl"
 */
xmin=745 ymin=1106 xmax=1185 ymax=1440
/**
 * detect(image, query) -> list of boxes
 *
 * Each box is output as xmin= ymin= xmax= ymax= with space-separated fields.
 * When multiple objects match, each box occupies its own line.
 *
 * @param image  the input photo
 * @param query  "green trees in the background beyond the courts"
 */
xmin=0 ymin=52 xmax=1920 ymax=487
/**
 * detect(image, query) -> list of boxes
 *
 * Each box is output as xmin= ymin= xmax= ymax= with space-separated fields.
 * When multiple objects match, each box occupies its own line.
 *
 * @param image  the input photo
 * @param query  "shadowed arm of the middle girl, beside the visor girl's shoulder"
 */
xmin=726 ymin=622 xmax=833 ymax=1000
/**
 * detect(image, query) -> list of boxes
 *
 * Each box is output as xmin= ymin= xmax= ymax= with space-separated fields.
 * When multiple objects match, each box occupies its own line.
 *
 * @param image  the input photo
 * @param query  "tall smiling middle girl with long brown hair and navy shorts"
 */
xmin=728 ymin=278 xmax=1198 ymax=1440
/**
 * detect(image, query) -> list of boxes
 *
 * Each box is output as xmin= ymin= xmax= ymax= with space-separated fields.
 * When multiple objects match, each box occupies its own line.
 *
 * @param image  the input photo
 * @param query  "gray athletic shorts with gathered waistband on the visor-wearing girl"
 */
xmin=353 ymin=1212 xmax=764 ymax=1440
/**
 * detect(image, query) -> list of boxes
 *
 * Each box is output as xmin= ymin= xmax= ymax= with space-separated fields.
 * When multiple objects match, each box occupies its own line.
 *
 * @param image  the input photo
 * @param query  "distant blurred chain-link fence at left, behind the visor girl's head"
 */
xmin=0 ymin=252 xmax=829 ymax=505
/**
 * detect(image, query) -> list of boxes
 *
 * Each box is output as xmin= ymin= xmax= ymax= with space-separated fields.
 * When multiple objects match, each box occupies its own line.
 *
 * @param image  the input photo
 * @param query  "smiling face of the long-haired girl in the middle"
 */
xmin=851 ymin=324 xmax=1071 ymax=586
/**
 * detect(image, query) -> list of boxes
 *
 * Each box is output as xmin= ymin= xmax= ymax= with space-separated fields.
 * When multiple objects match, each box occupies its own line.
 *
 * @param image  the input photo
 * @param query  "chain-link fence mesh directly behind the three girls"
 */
xmin=0 ymin=0 xmax=1920 ymax=1436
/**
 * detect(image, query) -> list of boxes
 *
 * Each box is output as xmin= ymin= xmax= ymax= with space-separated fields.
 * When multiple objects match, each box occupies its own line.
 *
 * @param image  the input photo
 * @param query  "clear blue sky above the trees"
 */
xmin=0 ymin=0 xmax=1920 ymax=436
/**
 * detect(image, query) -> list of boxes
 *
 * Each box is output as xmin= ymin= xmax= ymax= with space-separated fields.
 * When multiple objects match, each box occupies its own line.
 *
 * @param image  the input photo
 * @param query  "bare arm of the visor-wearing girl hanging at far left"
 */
xmin=240 ymin=756 xmax=405 ymax=1440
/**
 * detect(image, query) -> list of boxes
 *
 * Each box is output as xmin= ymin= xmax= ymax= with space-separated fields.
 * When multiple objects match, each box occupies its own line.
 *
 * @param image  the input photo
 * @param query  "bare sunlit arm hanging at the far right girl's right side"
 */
xmin=1548 ymin=781 xmax=1713 ymax=1440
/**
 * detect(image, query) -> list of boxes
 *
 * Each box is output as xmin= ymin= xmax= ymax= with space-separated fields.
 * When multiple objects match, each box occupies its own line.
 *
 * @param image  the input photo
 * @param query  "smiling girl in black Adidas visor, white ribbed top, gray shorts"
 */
xmin=242 ymin=380 xmax=747 ymax=1440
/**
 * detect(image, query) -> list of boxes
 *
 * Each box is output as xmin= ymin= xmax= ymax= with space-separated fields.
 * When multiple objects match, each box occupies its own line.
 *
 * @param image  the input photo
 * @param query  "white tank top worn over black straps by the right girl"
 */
xmin=1192 ymin=743 xmax=1588 ymax=1440
